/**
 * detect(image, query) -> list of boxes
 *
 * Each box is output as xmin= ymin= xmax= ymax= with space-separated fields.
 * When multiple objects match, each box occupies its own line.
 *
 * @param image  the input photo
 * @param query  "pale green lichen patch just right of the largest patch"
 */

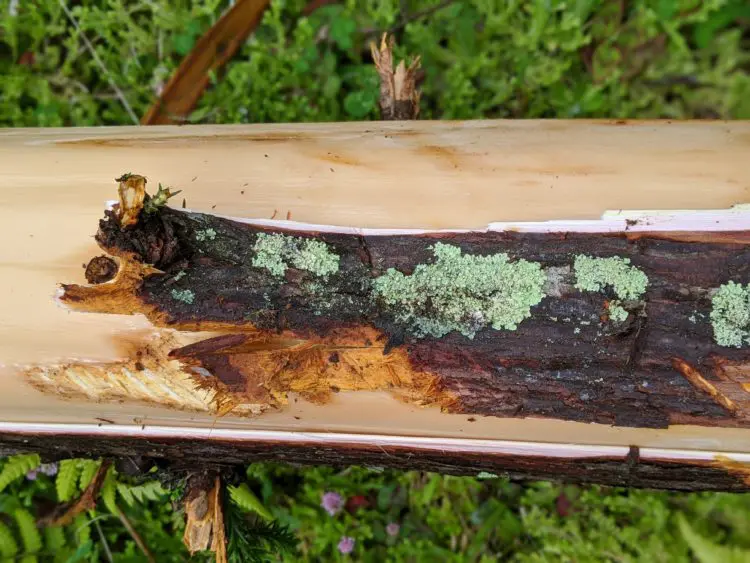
xmin=573 ymin=255 xmax=648 ymax=299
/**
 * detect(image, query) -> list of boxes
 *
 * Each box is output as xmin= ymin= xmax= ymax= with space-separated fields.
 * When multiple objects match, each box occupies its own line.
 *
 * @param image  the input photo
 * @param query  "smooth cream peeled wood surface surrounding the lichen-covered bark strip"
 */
xmin=0 ymin=121 xmax=750 ymax=474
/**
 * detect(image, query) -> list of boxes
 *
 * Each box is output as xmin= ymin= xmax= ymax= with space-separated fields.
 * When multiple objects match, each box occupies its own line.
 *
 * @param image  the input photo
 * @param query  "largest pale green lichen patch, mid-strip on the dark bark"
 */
xmin=373 ymin=243 xmax=546 ymax=338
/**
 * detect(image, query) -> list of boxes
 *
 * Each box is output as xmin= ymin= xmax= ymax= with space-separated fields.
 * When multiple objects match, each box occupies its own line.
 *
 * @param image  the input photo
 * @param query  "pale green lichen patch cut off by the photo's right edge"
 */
xmin=711 ymin=281 xmax=750 ymax=348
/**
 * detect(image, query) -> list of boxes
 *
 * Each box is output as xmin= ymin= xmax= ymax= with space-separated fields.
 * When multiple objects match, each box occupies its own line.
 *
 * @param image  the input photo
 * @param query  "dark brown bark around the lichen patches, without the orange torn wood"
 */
xmin=64 ymin=208 xmax=750 ymax=428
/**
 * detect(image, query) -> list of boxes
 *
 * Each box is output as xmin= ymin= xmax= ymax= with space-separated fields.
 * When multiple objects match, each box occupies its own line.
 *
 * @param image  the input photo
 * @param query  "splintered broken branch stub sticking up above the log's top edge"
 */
xmin=370 ymin=33 xmax=420 ymax=121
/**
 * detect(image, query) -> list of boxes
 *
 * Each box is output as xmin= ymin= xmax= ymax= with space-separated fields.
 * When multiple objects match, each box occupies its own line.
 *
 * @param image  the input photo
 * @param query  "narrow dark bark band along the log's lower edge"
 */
xmin=0 ymin=434 xmax=750 ymax=491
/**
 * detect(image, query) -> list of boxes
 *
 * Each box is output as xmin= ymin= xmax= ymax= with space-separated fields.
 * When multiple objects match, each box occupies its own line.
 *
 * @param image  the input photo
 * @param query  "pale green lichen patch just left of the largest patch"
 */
xmin=252 ymin=233 xmax=339 ymax=278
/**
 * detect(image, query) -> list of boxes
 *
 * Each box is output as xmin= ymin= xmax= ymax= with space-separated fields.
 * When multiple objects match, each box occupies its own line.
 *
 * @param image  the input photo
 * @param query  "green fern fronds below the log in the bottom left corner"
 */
xmin=0 ymin=458 xmax=210 ymax=563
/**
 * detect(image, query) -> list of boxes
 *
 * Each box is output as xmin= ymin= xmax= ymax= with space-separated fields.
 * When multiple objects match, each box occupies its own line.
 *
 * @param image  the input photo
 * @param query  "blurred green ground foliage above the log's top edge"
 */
xmin=0 ymin=0 xmax=750 ymax=126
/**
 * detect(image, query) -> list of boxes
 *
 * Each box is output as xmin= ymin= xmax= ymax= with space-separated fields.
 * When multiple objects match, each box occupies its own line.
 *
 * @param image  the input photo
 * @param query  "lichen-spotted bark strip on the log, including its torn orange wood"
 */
xmin=32 ymin=176 xmax=750 ymax=428
